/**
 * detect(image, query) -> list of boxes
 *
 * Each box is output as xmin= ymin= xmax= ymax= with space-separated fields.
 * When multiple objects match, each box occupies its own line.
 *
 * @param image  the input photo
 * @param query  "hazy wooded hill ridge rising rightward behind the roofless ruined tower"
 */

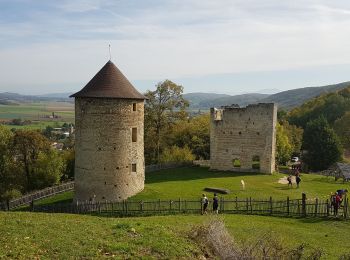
xmin=259 ymin=81 xmax=350 ymax=110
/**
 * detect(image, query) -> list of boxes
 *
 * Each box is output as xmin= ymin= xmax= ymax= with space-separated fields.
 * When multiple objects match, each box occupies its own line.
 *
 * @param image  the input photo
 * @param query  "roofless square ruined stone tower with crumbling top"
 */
xmin=210 ymin=103 xmax=277 ymax=173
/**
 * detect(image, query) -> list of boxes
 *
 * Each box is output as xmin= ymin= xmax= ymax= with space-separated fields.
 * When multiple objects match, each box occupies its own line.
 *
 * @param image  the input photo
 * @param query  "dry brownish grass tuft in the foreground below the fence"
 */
xmin=190 ymin=216 xmax=323 ymax=260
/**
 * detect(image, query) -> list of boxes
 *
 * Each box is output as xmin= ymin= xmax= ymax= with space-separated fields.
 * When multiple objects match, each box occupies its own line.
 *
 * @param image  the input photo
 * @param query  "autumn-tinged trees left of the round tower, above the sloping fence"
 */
xmin=0 ymin=125 xmax=74 ymax=201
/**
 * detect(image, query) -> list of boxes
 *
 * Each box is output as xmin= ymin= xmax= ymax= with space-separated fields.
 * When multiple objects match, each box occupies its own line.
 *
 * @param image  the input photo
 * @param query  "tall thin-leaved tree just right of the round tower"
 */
xmin=145 ymin=80 xmax=188 ymax=163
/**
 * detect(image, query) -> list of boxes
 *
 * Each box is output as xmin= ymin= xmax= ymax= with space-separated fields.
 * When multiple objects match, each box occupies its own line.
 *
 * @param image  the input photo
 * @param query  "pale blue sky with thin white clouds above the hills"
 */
xmin=0 ymin=0 xmax=350 ymax=94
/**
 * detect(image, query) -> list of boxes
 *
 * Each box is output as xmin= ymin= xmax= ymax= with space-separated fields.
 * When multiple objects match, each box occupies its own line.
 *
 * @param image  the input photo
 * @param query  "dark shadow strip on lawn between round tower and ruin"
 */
xmin=145 ymin=167 xmax=264 ymax=184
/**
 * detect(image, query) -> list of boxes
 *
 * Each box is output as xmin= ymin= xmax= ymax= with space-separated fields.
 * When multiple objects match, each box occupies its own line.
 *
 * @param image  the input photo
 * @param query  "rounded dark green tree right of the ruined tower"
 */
xmin=302 ymin=117 xmax=342 ymax=171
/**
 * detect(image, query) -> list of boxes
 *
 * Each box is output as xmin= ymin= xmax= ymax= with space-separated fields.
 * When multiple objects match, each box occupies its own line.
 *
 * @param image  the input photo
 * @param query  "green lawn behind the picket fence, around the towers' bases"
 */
xmin=37 ymin=167 xmax=350 ymax=204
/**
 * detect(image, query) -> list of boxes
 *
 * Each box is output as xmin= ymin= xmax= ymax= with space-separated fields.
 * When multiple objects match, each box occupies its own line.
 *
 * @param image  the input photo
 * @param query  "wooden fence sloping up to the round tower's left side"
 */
xmin=0 ymin=181 xmax=74 ymax=210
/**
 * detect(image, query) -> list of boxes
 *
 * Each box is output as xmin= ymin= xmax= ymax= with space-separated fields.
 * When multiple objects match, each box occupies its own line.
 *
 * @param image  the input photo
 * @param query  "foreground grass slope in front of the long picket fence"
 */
xmin=0 ymin=212 xmax=350 ymax=259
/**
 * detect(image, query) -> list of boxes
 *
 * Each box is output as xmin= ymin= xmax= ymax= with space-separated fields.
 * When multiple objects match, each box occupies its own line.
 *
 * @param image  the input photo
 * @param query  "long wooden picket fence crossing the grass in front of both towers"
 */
xmin=32 ymin=196 xmax=349 ymax=219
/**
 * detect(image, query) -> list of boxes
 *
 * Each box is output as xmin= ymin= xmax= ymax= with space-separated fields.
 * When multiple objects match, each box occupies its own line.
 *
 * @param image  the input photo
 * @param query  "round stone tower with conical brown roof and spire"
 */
xmin=71 ymin=61 xmax=145 ymax=202
